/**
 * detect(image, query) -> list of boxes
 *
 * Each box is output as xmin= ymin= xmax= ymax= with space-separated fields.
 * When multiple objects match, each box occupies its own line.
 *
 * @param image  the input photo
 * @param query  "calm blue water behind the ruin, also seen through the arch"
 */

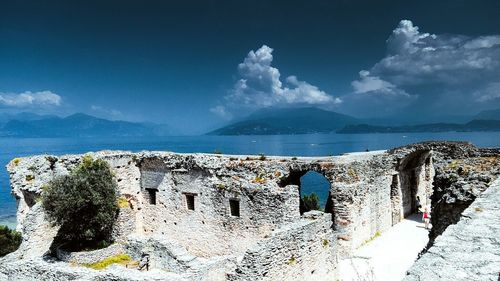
xmin=0 ymin=132 xmax=500 ymax=228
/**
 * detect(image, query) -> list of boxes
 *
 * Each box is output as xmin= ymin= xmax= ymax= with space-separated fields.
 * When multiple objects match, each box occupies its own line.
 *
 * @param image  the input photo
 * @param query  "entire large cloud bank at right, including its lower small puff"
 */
xmin=344 ymin=20 xmax=500 ymax=117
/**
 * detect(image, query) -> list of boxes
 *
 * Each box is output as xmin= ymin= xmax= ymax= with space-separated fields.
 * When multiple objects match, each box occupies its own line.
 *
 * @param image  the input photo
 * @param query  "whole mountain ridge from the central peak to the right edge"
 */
xmin=207 ymin=107 xmax=500 ymax=135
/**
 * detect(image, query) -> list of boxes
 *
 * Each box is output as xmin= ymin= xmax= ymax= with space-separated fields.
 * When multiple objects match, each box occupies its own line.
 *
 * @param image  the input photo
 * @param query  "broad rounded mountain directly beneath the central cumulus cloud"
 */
xmin=208 ymin=107 xmax=359 ymax=135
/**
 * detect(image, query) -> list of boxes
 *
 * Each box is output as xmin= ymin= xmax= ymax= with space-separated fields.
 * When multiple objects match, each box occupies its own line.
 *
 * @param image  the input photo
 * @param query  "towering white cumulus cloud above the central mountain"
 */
xmin=210 ymin=45 xmax=341 ymax=118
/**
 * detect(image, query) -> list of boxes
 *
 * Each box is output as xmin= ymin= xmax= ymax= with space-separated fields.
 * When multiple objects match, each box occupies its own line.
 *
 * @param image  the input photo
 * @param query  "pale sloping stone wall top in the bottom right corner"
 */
xmin=404 ymin=177 xmax=500 ymax=281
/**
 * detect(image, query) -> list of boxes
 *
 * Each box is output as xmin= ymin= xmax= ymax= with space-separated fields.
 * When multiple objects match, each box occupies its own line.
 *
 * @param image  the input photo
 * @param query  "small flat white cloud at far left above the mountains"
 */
xmin=0 ymin=91 xmax=62 ymax=108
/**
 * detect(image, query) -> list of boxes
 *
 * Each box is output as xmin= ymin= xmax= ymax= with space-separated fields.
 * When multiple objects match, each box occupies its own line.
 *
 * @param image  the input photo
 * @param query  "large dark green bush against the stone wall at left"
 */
xmin=42 ymin=156 xmax=118 ymax=250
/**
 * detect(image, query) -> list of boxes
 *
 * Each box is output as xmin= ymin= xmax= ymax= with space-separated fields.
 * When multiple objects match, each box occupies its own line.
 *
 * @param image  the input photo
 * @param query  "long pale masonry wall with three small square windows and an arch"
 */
xmin=9 ymin=149 xmax=414 ymax=257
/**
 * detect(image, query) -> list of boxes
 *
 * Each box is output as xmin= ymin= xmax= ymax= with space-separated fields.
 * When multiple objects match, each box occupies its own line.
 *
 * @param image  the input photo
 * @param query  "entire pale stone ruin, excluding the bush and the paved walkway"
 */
xmin=0 ymin=142 xmax=500 ymax=280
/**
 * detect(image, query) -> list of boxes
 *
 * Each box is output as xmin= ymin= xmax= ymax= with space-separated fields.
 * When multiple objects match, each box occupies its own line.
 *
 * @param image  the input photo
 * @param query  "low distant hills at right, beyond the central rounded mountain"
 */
xmin=337 ymin=120 xmax=500 ymax=134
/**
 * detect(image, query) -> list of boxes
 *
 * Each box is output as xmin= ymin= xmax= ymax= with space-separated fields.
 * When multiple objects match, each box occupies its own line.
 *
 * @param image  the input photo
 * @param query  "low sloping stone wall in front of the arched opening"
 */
xmin=228 ymin=211 xmax=337 ymax=281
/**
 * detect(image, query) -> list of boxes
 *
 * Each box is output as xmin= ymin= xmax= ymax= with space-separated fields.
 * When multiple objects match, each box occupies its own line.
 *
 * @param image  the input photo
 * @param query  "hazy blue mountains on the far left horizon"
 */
xmin=0 ymin=113 xmax=172 ymax=137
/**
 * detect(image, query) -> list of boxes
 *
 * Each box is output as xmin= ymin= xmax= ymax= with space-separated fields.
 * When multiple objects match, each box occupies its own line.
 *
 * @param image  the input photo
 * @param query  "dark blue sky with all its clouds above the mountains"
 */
xmin=0 ymin=0 xmax=500 ymax=132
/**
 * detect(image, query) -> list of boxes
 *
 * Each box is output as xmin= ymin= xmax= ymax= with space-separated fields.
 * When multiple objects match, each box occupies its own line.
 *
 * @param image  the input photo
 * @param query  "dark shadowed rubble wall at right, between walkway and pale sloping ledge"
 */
xmin=389 ymin=142 xmax=500 ymax=249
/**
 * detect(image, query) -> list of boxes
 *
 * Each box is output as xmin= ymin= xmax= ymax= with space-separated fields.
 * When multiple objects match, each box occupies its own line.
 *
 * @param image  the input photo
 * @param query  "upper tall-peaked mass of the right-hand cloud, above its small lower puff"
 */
xmin=370 ymin=20 xmax=500 ymax=86
